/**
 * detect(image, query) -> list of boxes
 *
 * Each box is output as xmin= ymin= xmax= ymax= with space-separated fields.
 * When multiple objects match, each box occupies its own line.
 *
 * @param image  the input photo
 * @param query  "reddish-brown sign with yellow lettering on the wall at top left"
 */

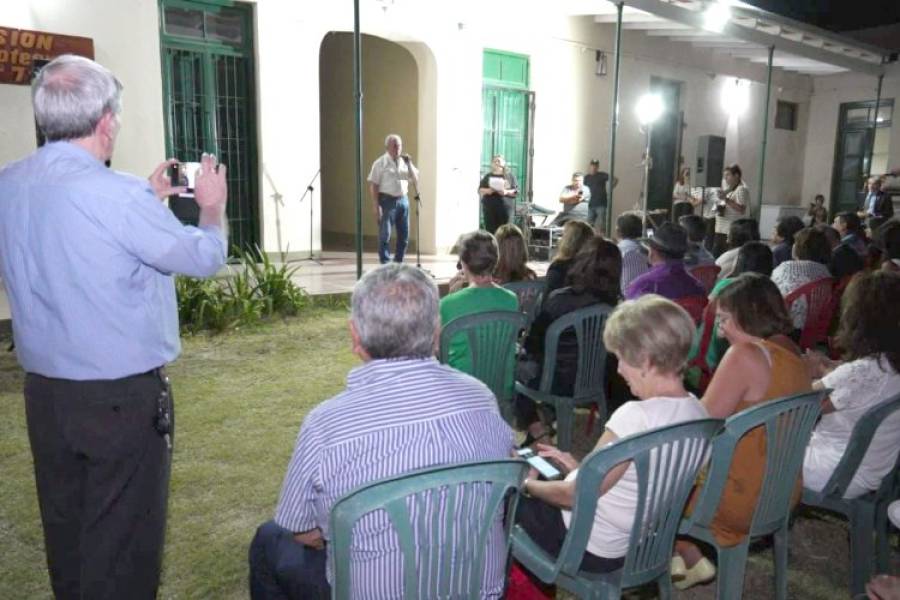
xmin=0 ymin=27 xmax=94 ymax=85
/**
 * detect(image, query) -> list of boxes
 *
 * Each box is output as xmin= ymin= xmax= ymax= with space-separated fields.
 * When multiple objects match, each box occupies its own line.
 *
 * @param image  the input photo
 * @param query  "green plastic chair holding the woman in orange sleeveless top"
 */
xmin=680 ymin=391 xmax=828 ymax=600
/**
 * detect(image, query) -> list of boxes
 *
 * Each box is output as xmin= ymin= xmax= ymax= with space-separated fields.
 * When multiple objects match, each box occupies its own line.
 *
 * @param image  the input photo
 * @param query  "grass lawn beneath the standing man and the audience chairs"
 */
xmin=0 ymin=308 xmax=900 ymax=600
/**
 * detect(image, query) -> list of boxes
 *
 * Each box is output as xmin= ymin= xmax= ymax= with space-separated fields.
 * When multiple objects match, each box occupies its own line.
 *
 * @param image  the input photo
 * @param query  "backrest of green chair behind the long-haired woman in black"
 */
xmin=540 ymin=304 xmax=612 ymax=404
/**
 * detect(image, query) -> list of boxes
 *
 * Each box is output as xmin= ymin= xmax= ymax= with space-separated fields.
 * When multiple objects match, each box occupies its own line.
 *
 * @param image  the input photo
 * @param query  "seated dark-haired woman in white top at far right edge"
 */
xmin=803 ymin=271 xmax=900 ymax=498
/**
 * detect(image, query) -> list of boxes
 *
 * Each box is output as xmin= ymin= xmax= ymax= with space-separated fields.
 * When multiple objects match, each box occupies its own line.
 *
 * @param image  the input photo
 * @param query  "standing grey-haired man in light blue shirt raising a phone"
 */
xmin=0 ymin=55 xmax=227 ymax=599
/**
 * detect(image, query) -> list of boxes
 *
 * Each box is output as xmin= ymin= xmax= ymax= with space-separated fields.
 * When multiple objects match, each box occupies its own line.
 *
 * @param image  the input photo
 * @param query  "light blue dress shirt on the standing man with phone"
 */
xmin=0 ymin=142 xmax=226 ymax=380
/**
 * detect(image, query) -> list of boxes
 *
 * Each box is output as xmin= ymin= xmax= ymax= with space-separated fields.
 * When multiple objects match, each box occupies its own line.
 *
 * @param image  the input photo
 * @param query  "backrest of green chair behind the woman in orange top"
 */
xmin=681 ymin=390 xmax=828 ymax=537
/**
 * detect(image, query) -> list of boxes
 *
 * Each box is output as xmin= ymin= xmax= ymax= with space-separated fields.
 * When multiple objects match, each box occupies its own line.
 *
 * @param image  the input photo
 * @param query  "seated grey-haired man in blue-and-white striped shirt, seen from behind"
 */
xmin=250 ymin=264 xmax=514 ymax=600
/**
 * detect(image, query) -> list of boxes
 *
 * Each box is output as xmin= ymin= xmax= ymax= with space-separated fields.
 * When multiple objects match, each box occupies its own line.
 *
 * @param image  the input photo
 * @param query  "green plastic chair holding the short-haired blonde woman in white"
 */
xmin=512 ymin=419 xmax=723 ymax=600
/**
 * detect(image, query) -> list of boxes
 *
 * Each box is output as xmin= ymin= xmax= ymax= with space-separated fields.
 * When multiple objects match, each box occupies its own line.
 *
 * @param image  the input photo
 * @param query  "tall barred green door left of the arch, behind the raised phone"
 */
xmin=160 ymin=0 xmax=260 ymax=248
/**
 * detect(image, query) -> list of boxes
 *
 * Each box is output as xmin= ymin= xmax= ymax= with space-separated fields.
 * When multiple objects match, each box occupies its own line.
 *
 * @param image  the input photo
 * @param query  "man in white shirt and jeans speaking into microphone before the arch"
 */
xmin=368 ymin=133 xmax=419 ymax=264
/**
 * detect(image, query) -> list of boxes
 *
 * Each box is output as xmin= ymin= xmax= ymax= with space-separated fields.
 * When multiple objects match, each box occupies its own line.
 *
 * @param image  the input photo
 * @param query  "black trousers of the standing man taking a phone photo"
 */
xmin=25 ymin=369 xmax=174 ymax=600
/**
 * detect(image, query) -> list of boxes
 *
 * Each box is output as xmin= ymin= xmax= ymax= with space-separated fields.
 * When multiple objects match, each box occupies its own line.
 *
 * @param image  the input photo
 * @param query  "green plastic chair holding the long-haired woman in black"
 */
xmin=516 ymin=304 xmax=612 ymax=450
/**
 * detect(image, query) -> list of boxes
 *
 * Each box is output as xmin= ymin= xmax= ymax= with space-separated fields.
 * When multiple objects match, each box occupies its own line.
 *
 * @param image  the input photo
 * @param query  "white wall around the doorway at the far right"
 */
xmin=803 ymin=65 xmax=900 ymax=205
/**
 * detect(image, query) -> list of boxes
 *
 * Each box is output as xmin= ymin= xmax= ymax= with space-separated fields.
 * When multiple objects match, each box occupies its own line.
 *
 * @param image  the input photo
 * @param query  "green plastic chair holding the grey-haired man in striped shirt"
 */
xmin=331 ymin=459 xmax=528 ymax=600
